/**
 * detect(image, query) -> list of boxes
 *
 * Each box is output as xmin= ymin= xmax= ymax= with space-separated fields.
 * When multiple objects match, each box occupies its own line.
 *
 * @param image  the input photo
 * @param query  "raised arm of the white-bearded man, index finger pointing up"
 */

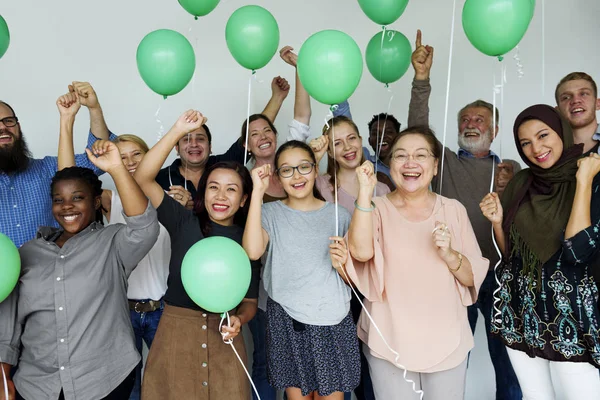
xmin=408 ymin=30 xmax=433 ymax=126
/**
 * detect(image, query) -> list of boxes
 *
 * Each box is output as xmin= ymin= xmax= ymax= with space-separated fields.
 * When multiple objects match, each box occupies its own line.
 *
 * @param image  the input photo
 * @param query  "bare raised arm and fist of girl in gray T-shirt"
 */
xmin=242 ymin=164 xmax=271 ymax=260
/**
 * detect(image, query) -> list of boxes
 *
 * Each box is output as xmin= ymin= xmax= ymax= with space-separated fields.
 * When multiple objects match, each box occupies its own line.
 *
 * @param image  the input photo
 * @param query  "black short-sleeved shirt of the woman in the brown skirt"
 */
xmin=156 ymin=196 xmax=260 ymax=310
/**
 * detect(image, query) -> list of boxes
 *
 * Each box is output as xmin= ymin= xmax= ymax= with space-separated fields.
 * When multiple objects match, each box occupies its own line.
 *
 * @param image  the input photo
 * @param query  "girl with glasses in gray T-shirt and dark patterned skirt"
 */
xmin=243 ymin=141 xmax=360 ymax=400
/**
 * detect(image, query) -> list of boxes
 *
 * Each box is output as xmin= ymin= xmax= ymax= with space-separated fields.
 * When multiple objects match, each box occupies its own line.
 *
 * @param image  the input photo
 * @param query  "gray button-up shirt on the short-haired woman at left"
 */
xmin=0 ymin=205 xmax=159 ymax=400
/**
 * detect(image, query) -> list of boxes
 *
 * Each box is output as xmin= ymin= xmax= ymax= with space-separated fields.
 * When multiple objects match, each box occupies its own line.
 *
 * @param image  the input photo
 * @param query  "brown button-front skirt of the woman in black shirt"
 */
xmin=142 ymin=305 xmax=250 ymax=400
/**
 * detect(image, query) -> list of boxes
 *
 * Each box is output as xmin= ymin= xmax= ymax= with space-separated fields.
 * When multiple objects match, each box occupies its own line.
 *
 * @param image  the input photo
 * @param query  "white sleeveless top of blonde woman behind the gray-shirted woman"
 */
xmin=109 ymin=190 xmax=171 ymax=300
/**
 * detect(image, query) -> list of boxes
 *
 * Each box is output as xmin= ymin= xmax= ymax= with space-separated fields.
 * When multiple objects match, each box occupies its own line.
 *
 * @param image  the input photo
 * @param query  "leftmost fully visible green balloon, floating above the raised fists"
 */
xmin=136 ymin=29 xmax=196 ymax=97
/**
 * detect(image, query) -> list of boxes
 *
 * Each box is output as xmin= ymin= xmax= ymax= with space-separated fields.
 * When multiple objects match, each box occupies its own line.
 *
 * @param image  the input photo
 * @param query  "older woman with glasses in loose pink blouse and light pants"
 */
xmin=346 ymin=128 xmax=489 ymax=400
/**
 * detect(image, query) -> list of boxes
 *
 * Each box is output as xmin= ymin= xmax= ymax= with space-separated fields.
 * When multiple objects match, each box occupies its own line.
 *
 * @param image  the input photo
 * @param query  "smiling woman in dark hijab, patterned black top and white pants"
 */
xmin=480 ymin=105 xmax=600 ymax=400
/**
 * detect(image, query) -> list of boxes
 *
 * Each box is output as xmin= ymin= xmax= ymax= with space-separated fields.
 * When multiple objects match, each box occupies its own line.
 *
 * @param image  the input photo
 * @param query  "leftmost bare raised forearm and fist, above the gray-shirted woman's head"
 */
xmin=56 ymin=92 xmax=81 ymax=171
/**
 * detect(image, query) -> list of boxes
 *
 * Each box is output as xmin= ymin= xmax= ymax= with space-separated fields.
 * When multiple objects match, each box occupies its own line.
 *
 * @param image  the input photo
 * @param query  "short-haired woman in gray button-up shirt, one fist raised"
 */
xmin=0 ymin=141 xmax=159 ymax=400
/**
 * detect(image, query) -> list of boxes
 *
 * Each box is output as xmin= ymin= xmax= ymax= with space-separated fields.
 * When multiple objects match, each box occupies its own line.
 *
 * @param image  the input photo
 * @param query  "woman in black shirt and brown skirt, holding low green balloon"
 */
xmin=135 ymin=110 xmax=260 ymax=400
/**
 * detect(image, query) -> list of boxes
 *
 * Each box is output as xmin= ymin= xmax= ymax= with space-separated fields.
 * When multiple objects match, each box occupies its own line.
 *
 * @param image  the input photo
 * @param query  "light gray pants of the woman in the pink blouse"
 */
xmin=363 ymin=345 xmax=467 ymax=400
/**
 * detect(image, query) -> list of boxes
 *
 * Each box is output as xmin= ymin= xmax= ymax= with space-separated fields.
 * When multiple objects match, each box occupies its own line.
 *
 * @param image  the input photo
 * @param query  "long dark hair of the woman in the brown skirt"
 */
xmin=194 ymin=161 xmax=253 ymax=236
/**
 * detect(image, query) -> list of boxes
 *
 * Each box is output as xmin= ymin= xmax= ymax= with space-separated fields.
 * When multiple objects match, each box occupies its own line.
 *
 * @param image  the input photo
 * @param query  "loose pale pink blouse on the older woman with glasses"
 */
xmin=346 ymin=196 xmax=491 ymax=372
